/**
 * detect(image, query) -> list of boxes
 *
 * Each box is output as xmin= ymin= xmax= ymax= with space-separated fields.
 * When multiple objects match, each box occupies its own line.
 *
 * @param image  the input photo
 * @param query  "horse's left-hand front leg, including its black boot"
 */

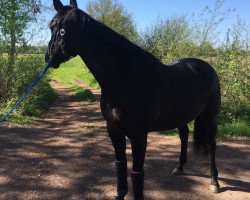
xmin=107 ymin=124 xmax=128 ymax=200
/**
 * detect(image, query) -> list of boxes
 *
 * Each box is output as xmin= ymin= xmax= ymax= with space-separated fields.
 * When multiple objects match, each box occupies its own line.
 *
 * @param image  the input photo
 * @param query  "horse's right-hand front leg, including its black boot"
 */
xmin=130 ymin=131 xmax=147 ymax=200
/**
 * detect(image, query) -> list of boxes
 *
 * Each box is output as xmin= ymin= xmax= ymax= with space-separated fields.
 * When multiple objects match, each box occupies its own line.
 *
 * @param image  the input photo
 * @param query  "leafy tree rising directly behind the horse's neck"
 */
xmin=87 ymin=0 xmax=138 ymax=41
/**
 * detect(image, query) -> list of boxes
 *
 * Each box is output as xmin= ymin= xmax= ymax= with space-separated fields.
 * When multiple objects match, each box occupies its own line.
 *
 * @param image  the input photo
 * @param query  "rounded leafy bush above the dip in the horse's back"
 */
xmin=141 ymin=15 xmax=196 ymax=64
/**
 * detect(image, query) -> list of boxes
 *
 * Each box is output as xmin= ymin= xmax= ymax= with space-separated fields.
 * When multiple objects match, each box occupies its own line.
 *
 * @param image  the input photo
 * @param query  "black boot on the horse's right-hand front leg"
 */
xmin=131 ymin=171 xmax=144 ymax=200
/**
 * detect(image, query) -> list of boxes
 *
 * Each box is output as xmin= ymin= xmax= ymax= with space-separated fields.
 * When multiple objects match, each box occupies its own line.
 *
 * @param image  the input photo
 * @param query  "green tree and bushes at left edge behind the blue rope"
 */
xmin=0 ymin=0 xmax=55 ymax=123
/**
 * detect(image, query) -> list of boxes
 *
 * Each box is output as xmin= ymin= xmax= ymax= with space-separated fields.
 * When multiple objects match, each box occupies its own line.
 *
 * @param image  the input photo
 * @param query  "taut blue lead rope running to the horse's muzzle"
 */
xmin=0 ymin=61 xmax=51 ymax=125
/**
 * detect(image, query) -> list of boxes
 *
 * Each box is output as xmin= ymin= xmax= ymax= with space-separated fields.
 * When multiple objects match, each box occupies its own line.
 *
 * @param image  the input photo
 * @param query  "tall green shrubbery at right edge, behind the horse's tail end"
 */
xmin=214 ymin=21 xmax=250 ymax=123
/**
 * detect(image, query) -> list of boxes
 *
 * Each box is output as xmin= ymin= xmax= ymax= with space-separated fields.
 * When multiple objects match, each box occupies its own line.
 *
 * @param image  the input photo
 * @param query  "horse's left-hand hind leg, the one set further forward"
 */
xmin=172 ymin=125 xmax=189 ymax=175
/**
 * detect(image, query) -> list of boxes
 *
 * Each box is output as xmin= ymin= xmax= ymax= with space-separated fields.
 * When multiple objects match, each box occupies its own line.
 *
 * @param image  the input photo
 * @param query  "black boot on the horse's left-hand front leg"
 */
xmin=115 ymin=160 xmax=128 ymax=200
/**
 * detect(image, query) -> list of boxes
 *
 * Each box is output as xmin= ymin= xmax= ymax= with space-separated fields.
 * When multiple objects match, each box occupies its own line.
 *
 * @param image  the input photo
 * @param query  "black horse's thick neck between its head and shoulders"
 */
xmin=79 ymin=21 xmax=164 ymax=93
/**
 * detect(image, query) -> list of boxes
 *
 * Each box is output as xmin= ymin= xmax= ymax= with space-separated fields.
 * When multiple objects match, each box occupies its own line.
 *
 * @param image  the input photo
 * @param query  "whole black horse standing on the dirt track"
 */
xmin=46 ymin=0 xmax=220 ymax=200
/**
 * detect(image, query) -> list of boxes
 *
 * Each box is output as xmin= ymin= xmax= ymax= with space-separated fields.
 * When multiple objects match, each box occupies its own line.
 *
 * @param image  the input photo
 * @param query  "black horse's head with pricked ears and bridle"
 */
xmin=45 ymin=0 xmax=87 ymax=68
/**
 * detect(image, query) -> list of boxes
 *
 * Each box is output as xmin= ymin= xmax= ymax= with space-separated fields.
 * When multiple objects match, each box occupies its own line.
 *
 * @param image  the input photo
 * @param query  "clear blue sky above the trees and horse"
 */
xmin=42 ymin=0 xmax=250 ymax=43
